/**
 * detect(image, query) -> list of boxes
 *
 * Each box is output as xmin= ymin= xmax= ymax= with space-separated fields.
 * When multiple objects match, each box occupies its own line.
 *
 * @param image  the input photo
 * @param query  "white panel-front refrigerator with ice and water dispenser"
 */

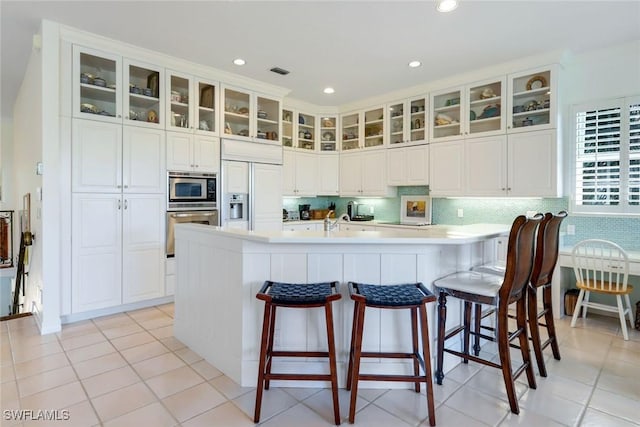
xmin=220 ymin=140 xmax=282 ymax=231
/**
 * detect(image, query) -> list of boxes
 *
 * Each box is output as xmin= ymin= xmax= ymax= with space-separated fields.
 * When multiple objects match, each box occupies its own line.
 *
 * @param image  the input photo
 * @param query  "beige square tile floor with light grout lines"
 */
xmin=0 ymin=304 xmax=640 ymax=427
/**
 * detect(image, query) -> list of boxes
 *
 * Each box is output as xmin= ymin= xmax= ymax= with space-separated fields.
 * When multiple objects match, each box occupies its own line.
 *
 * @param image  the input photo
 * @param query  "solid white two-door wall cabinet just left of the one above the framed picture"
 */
xmin=340 ymin=150 xmax=396 ymax=197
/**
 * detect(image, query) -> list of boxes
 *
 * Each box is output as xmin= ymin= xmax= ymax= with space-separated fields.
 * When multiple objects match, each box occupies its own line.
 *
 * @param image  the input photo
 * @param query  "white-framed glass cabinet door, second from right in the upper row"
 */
xmin=462 ymin=78 xmax=505 ymax=136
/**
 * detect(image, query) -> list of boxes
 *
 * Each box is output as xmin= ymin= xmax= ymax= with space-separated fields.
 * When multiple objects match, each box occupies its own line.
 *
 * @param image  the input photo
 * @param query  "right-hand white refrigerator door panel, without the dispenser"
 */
xmin=249 ymin=163 xmax=282 ymax=231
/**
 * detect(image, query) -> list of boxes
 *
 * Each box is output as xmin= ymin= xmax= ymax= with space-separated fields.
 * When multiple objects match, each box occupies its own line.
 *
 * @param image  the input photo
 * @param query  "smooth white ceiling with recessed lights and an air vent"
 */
xmin=0 ymin=0 xmax=640 ymax=117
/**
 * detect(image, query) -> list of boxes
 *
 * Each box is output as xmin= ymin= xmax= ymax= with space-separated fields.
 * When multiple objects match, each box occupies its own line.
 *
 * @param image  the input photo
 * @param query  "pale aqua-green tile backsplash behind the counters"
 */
xmin=283 ymin=186 xmax=640 ymax=251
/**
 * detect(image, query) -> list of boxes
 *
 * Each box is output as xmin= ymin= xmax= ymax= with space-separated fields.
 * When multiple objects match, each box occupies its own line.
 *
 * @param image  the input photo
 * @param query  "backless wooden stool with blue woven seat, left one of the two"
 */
xmin=253 ymin=281 xmax=341 ymax=425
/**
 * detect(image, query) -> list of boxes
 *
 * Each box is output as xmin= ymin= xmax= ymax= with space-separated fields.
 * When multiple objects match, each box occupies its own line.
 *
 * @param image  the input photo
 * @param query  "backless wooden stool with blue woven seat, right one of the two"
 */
xmin=346 ymin=282 xmax=436 ymax=426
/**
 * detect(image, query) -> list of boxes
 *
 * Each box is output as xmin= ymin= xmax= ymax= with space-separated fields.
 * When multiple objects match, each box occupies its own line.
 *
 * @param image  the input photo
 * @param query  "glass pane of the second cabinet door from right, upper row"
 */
xmin=469 ymin=81 xmax=502 ymax=134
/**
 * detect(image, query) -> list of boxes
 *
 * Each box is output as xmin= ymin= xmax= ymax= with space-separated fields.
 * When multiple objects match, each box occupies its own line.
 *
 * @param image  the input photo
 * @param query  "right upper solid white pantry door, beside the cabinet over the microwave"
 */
xmin=122 ymin=126 xmax=167 ymax=194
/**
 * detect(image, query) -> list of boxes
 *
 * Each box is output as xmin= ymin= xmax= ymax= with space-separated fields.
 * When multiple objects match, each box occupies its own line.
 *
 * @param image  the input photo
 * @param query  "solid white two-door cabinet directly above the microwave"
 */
xmin=167 ymin=132 xmax=220 ymax=173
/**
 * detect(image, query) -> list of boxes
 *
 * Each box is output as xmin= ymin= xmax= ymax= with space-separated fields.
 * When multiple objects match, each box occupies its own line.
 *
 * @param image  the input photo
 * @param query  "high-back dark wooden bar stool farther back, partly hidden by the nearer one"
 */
xmin=473 ymin=211 xmax=567 ymax=377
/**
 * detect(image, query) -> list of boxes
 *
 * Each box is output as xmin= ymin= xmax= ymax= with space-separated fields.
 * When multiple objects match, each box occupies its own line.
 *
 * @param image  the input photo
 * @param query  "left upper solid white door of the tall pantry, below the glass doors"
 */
xmin=71 ymin=119 xmax=122 ymax=193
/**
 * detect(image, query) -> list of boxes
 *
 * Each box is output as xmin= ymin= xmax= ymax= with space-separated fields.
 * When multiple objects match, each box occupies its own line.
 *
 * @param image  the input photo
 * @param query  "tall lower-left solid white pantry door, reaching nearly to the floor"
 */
xmin=71 ymin=194 xmax=122 ymax=313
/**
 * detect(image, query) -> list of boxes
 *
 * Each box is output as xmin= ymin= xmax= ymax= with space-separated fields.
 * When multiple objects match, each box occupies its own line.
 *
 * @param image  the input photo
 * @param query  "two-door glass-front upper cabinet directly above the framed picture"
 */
xmin=387 ymin=96 xmax=428 ymax=146
